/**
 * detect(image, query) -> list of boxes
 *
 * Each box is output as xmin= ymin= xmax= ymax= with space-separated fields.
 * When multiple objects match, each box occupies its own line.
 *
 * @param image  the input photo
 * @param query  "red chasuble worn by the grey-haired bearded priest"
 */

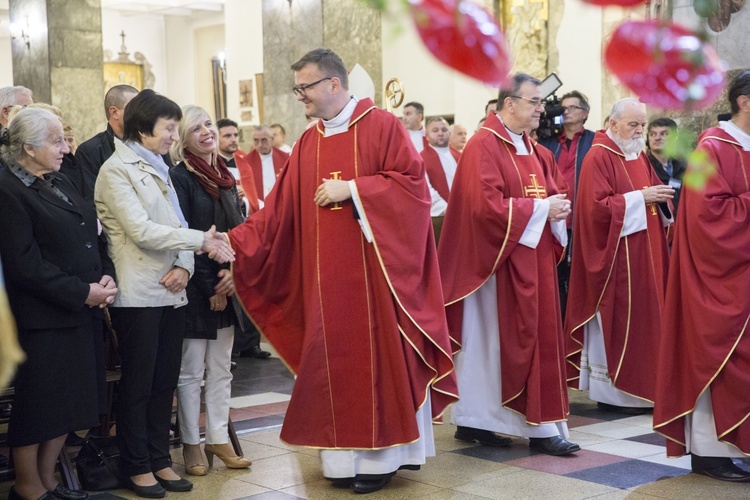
xmin=565 ymin=131 xmax=669 ymax=401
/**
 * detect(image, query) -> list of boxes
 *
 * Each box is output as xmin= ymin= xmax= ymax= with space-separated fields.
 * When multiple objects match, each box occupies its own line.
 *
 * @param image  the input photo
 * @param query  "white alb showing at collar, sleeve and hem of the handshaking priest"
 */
xmin=320 ymin=96 xmax=435 ymax=479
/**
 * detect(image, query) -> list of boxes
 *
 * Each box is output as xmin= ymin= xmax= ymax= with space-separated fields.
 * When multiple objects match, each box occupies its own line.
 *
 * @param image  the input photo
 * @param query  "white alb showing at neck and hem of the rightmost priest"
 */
xmin=685 ymin=121 xmax=750 ymax=457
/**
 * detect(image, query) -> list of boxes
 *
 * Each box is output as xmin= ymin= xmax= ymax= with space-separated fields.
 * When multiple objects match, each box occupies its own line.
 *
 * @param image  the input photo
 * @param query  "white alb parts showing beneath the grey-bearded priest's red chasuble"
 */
xmin=578 ymin=130 xmax=674 ymax=408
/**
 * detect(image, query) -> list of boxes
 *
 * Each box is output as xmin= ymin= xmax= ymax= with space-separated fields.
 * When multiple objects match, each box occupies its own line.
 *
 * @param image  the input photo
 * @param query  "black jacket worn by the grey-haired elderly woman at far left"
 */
xmin=0 ymin=168 xmax=116 ymax=329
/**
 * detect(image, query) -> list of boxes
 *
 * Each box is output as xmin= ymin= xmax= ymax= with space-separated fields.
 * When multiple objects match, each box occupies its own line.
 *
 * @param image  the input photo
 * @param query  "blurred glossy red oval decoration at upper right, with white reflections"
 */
xmin=604 ymin=20 xmax=724 ymax=110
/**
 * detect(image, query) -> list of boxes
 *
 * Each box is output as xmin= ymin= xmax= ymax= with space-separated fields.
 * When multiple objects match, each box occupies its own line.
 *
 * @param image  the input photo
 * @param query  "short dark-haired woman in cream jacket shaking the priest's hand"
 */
xmin=94 ymin=90 xmax=233 ymax=498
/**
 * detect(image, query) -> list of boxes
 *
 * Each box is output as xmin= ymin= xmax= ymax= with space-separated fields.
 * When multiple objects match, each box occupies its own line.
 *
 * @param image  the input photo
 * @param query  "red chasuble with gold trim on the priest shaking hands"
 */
xmin=229 ymin=99 xmax=457 ymax=449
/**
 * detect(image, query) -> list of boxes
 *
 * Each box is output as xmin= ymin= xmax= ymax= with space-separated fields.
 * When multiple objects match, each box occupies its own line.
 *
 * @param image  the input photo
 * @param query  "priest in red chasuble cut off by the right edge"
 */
xmin=654 ymin=71 xmax=750 ymax=482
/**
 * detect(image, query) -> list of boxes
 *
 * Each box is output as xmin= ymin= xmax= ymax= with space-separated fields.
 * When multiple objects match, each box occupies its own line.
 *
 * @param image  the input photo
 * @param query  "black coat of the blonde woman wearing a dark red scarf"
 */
xmin=169 ymin=163 xmax=242 ymax=339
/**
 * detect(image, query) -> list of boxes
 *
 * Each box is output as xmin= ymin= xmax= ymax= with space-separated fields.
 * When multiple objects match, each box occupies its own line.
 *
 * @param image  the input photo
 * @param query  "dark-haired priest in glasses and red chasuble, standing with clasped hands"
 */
xmin=438 ymin=74 xmax=580 ymax=455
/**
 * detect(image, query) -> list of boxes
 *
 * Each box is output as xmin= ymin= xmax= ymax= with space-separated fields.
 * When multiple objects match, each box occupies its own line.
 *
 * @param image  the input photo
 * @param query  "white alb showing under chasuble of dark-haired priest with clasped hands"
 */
xmin=451 ymin=127 xmax=569 ymax=438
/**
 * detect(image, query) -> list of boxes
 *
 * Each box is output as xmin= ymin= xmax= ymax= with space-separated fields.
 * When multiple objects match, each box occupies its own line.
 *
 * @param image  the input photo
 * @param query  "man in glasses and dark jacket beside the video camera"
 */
xmin=539 ymin=90 xmax=594 ymax=319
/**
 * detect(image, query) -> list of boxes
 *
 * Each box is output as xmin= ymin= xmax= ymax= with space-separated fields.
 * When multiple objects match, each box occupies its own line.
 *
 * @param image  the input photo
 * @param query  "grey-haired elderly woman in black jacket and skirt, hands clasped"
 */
xmin=0 ymin=109 xmax=117 ymax=499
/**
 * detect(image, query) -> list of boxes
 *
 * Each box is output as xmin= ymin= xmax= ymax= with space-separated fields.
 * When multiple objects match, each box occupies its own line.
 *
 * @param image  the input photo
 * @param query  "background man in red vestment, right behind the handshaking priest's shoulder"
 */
xmin=419 ymin=116 xmax=461 ymax=243
